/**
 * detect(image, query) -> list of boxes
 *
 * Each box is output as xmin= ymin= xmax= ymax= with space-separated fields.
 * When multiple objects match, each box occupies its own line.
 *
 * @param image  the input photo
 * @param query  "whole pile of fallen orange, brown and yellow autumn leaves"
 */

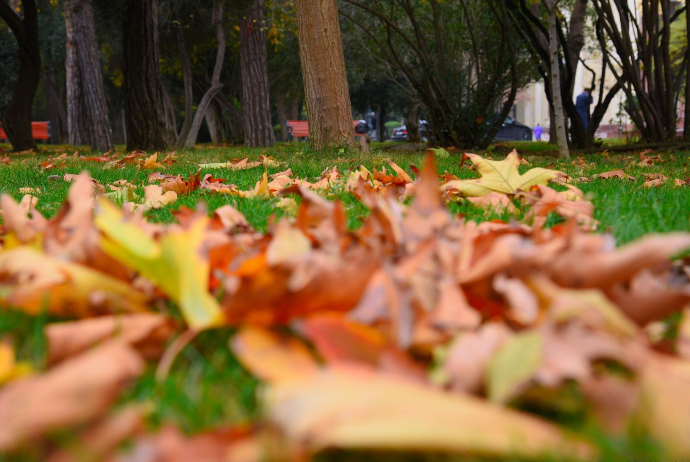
xmin=0 ymin=154 xmax=690 ymax=462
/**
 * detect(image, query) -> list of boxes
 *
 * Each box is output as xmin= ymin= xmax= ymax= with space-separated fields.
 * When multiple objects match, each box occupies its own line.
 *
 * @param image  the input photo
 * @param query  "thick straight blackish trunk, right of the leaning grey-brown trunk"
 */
xmin=123 ymin=0 xmax=172 ymax=151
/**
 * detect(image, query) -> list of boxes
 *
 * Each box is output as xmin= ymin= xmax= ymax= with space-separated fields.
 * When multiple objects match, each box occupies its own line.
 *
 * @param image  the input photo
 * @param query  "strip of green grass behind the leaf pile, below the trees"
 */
xmin=0 ymin=142 xmax=690 ymax=244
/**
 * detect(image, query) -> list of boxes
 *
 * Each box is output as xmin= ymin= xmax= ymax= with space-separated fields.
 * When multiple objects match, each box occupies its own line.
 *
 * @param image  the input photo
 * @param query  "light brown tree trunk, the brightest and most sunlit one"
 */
xmin=295 ymin=0 xmax=356 ymax=149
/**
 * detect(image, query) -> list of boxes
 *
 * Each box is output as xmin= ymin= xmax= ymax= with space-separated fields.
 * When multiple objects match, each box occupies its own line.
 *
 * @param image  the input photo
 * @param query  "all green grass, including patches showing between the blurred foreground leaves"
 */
xmin=0 ymin=144 xmax=690 ymax=460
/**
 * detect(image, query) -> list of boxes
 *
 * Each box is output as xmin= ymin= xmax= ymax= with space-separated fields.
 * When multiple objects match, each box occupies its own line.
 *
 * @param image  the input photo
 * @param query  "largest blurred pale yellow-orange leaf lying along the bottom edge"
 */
xmin=266 ymin=366 xmax=596 ymax=460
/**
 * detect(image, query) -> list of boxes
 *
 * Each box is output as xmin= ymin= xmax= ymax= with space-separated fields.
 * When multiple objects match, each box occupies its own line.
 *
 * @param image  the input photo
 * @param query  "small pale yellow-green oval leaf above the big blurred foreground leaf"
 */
xmin=487 ymin=331 xmax=544 ymax=403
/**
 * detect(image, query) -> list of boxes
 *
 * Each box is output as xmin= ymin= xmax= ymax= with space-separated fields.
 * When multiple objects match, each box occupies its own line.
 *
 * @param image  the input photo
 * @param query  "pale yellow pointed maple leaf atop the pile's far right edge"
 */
xmin=441 ymin=151 xmax=567 ymax=197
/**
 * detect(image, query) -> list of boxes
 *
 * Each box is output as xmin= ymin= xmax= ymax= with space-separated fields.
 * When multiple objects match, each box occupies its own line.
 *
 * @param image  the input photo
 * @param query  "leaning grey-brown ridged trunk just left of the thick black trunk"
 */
xmin=65 ymin=0 xmax=113 ymax=151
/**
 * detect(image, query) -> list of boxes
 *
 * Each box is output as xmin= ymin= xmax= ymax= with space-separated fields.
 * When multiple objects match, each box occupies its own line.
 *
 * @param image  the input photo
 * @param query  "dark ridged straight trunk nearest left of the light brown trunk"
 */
xmin=240 ymin=0 xmax=275 ymax=147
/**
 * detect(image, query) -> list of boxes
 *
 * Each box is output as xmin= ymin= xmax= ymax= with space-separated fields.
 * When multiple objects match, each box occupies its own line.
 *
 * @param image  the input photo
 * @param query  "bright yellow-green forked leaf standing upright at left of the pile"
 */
xmin=95 ymin=200 xmax=223 ymax=329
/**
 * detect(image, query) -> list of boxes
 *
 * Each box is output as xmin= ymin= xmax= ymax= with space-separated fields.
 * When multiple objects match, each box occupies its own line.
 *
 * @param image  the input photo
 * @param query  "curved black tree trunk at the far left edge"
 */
xmin=0 ymin=0 xmax=41 ymax=151
